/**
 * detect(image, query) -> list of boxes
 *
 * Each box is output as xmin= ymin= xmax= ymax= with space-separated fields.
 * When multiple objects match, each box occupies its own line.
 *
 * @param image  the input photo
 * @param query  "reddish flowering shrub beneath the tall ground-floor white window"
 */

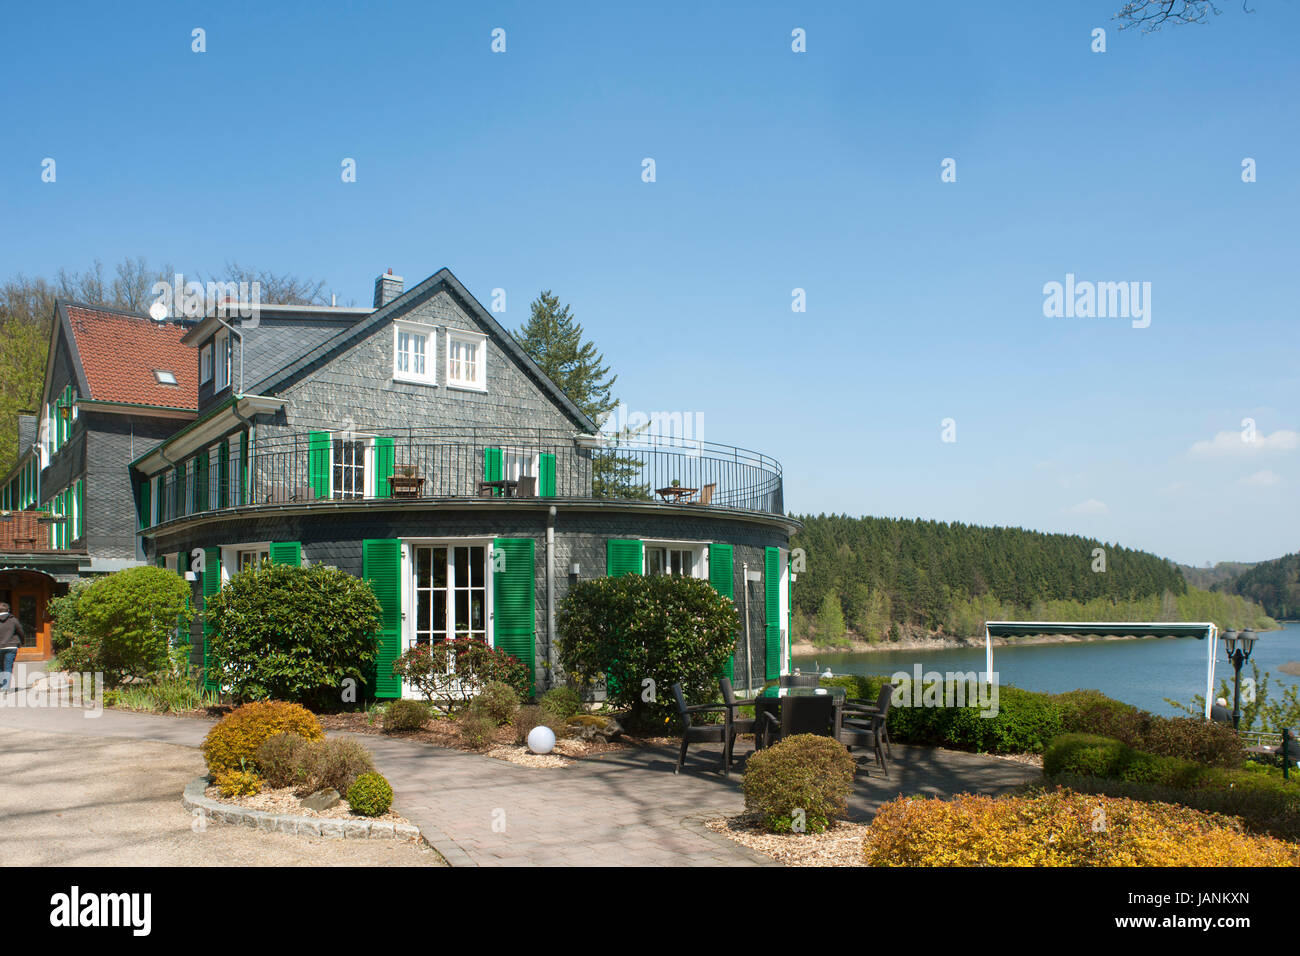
xmin=393 ymin=637 xmax=533 ymax=713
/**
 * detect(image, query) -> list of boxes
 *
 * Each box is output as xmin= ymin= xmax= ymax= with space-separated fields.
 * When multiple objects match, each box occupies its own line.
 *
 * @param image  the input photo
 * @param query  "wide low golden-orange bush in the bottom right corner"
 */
xmin=863 ymin=790 xmax=1300 ymax=866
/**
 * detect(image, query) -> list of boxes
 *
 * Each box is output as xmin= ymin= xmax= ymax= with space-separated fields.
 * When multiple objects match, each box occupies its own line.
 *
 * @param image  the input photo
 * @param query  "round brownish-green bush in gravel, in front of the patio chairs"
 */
xmin=742 ymin=734 xmax=857 ymax=834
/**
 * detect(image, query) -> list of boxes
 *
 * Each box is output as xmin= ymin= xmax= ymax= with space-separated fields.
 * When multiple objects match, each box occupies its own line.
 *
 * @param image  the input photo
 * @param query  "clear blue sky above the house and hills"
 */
xmin=0 ymin=0 xmax=1300 ymax=563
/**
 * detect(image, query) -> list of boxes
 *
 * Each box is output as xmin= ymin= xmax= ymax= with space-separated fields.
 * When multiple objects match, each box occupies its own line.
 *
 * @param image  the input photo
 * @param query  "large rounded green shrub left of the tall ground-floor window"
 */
xmin=200 ymin=563 xmax=381 ymax=708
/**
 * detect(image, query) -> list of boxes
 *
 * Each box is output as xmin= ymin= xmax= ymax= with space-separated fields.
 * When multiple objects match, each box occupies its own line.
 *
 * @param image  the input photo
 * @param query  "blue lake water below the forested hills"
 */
xmin=794 ymin=622 xmax=1300 ymax=714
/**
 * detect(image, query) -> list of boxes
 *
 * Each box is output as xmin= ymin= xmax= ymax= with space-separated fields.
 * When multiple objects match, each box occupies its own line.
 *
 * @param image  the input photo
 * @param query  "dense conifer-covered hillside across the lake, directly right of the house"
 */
xmin=792 ymin=515 xmax=1269 ymax=644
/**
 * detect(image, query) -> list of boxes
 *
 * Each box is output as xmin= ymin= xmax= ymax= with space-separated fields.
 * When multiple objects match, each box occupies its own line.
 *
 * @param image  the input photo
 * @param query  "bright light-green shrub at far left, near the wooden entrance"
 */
xmin=73 ymin=567 xmax=194 ymax=687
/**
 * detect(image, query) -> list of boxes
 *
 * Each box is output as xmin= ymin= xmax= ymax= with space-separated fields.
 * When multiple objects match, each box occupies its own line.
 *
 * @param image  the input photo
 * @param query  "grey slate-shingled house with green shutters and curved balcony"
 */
xmin=0 ymin=269 xmax=796 ymax=697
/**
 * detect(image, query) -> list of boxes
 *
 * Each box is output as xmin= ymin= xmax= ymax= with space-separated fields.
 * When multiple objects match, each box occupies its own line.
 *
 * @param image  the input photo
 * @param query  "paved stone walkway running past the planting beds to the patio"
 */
xmin=0 ymin=708 xmax=1039 ymax=866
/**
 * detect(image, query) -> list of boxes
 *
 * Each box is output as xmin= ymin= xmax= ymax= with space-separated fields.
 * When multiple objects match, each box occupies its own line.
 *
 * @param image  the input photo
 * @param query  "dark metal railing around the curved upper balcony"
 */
xmin=146 ymin=432 xmax=784 ymax=524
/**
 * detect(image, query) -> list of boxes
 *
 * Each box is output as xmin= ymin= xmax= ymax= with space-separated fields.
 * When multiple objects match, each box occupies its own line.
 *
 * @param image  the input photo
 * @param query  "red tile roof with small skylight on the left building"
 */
xmin=68 ymin=306 xmax=199 ymax=408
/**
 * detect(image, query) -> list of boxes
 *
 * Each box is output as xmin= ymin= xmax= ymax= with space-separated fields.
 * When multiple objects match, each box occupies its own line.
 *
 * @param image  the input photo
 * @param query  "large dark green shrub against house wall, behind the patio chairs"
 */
xmin=556 ymin=575 xmax=740 ymax=727
